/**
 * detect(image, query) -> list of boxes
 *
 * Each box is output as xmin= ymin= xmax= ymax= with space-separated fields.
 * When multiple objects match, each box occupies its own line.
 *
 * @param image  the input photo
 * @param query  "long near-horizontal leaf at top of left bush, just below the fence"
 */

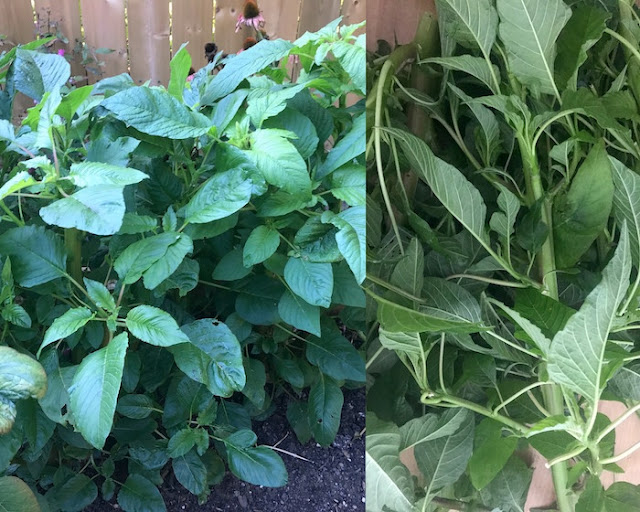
xmin=102 ymin=87 xmax=211 ymax=139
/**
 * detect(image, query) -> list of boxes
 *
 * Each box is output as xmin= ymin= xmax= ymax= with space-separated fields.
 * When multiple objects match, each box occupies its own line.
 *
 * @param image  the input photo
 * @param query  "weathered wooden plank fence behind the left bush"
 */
xmin=0 ymin=0 xmax=366 ymax=84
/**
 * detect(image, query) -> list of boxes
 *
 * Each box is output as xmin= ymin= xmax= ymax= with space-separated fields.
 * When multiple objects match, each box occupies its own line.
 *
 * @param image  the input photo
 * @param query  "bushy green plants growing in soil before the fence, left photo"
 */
xmin=0 ymin=20 xmax=366 ymax=512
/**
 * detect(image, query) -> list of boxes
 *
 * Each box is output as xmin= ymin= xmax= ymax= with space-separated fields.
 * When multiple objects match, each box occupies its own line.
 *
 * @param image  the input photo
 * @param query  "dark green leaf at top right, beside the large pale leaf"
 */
xmin=555 ymin=5 xmax=610 ymax=90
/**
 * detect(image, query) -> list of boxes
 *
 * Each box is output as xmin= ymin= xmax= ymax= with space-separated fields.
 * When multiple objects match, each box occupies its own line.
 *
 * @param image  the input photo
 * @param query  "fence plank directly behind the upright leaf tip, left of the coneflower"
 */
xmin=171 ymin=0 xmax=213 ymax=69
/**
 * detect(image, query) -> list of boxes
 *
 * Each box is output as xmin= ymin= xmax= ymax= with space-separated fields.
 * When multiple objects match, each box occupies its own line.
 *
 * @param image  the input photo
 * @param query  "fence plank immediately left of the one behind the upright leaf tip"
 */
xmin=127 ymin=0 xmax=170 ymax=85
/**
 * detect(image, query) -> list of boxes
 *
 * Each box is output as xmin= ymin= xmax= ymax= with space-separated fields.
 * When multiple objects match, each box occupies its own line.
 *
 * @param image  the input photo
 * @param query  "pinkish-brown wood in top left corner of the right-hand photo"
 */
xmin=367 ymin=0 xmax=435 ymax=50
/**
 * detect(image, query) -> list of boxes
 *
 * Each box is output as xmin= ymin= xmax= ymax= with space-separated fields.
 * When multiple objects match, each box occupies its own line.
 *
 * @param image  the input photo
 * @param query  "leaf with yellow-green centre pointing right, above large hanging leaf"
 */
xmin=126 ymin=305 xmax=189 ymax=347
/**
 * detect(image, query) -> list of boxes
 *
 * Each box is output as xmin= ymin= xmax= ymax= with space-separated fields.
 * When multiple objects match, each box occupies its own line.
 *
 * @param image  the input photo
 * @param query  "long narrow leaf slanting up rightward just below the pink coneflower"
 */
xmin=202 ymin=39 xmax=293 ymax=105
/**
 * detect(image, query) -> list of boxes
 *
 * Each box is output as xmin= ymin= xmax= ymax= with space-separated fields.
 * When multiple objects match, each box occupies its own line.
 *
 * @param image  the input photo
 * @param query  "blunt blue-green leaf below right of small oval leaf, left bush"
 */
xmin=284 ymin=258 xmax=333 ymax=308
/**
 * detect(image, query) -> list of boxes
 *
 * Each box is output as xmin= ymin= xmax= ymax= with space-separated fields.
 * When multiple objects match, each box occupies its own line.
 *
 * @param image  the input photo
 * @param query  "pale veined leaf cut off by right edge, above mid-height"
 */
xmin=609 ymin=157 xmax=640 ymax=267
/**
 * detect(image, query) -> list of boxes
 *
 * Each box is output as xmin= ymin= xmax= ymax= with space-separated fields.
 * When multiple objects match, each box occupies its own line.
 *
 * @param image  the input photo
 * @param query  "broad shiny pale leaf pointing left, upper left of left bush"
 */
xmin=40 ymin=185 xmax=125 ymax=235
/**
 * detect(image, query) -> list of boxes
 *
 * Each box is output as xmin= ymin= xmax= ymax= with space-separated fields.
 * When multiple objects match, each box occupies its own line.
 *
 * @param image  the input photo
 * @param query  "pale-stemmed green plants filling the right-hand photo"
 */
xmin=366 ymin=0 xmax=640 ymax=512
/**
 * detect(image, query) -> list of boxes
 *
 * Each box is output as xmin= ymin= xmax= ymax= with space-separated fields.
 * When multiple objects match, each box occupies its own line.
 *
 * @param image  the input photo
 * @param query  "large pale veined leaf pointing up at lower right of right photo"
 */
xmin=548 ymin=224 xmax=631 ymax=406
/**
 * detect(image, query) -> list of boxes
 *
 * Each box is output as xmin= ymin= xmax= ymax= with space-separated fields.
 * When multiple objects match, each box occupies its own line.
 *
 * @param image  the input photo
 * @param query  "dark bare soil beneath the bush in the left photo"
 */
xmin=86 ymin=389 xmax=365 ymax=512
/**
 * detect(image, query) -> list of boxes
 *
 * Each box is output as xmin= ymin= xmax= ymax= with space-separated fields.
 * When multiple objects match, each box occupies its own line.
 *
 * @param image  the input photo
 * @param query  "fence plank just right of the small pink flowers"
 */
xmin=80 ymin=0 xmax=128 ymax=83
